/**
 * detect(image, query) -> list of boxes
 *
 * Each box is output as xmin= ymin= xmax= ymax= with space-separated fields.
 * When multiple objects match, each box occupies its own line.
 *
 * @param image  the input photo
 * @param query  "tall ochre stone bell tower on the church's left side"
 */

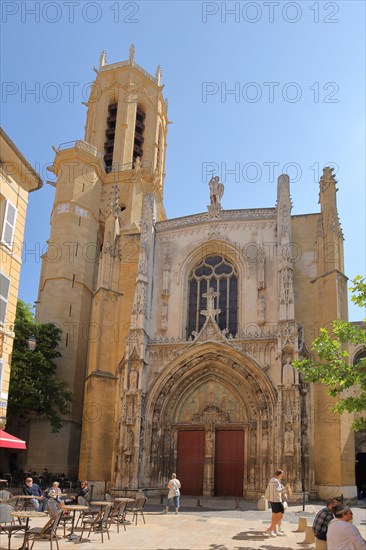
xmin=27 ymin=45 xmax=168 ymax=480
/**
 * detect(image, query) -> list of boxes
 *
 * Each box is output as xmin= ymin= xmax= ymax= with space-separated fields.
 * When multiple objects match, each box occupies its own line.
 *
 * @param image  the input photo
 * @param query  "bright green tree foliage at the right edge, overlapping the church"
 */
xmin=293 ymin=275 xmax=366 ymax=431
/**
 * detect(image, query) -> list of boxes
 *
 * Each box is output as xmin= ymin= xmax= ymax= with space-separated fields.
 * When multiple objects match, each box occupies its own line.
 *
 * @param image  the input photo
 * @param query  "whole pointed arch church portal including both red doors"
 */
xmin=144 ymin=342 xmax=275 ymax=496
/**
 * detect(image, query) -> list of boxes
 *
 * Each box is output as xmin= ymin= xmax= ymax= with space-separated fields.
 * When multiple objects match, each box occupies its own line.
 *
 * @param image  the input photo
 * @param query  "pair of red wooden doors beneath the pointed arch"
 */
xmin=177 ymin=430 xmax=244 ymax=496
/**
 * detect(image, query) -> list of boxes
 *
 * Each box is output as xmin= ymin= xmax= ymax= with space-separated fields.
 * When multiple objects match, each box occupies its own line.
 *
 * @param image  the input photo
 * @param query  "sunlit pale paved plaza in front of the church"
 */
xmin=1 ymin=498 xmax=366 ymax=550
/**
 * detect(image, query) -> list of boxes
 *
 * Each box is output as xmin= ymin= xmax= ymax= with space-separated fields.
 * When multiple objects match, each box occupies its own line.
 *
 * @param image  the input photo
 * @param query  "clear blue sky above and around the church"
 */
xmin=1 ymin=0 xmax=365 ymax=320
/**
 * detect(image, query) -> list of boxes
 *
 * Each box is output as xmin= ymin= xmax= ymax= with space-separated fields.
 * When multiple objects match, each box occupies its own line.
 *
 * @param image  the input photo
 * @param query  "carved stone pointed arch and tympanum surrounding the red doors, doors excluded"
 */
xmin=136 ymin=342 xmax=276 ymax=494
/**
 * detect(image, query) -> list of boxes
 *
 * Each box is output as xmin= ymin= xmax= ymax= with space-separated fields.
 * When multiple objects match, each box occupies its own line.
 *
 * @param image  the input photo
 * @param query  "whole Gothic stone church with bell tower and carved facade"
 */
xmin=27 ymin=51 xmax=355 ymax=498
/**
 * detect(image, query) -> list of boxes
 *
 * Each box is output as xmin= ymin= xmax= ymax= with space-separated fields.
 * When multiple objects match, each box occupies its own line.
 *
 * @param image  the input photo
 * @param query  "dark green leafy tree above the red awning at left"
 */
xmin=8 ymin=300 xmax=73 ymax=432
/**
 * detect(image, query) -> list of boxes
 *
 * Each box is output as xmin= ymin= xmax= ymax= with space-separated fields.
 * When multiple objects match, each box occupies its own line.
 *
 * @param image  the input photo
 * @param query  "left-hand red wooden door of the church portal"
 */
xmin=177 ymin=430 xmax=205 ymax=496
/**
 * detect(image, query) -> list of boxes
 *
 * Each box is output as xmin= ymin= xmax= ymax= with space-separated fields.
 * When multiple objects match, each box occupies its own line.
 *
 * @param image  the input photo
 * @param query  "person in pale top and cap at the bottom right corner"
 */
xmin=327 ymin=508 xmax=366 ymax=550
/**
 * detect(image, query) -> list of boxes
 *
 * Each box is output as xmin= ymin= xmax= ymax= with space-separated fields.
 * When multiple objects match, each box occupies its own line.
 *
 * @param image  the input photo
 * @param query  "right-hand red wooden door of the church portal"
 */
xmin=215 ymin=430 xmax=244 ymax=496
